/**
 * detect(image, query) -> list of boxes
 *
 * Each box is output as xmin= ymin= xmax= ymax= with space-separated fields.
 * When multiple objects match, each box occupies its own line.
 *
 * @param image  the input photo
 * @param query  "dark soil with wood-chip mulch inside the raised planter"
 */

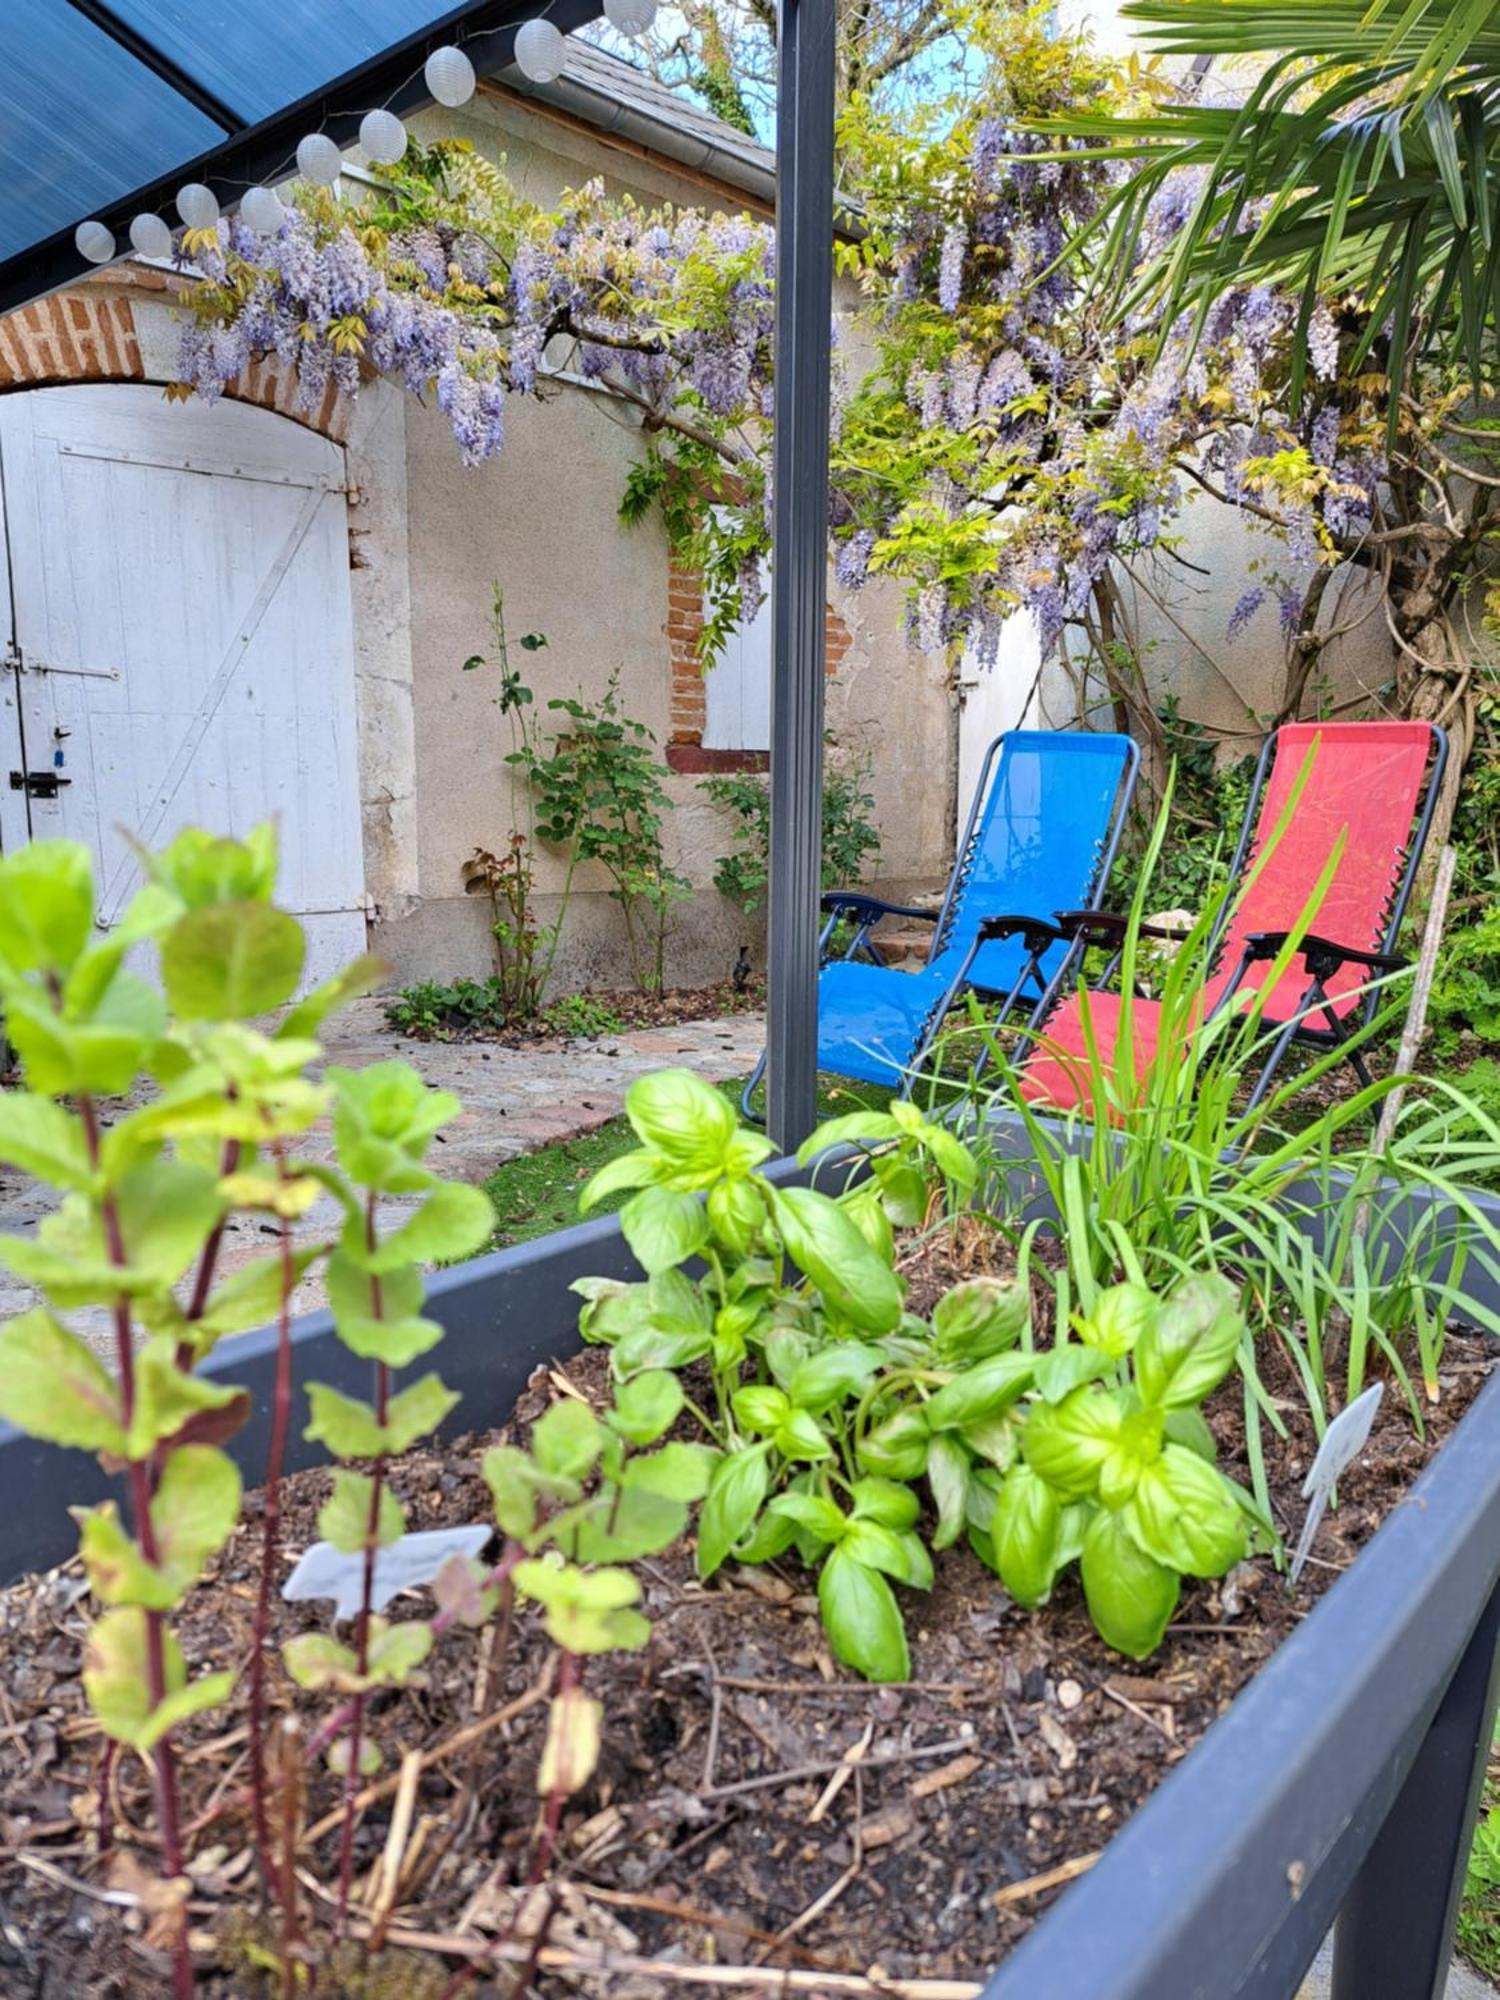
xmin=0 ymin=1304 xmax=1492 ymax=2000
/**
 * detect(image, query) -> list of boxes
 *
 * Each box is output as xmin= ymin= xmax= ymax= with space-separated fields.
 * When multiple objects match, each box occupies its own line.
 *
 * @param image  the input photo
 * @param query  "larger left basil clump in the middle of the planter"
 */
xmin=576 ymin=1070 xmax=1030 ymax=1680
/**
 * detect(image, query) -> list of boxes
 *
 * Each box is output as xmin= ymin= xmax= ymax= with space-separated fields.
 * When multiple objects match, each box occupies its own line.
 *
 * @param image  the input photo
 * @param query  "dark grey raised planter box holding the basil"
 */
xmin=0 ymin=1116 xmax=1500 ymax=2000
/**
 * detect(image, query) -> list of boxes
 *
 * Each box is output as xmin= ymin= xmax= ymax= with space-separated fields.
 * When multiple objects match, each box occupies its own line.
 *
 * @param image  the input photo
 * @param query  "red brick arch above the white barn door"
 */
xmin=0 ymin=282 xmax=350 ymax=444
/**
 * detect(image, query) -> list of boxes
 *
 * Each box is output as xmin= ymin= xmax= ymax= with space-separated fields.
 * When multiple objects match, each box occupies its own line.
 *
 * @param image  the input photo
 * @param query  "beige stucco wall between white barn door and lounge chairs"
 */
xmin=368 ymin=94 xmax=954 ymax=990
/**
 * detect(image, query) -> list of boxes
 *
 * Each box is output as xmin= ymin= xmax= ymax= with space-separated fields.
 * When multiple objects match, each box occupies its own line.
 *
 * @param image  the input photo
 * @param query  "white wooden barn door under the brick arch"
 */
xmin=0 ymin=384 xmax=364 ymax=980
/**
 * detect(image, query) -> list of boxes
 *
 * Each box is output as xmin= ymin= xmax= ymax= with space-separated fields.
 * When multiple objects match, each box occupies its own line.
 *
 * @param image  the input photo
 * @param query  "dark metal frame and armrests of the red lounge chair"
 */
xmin=1026 ymin=722 xmax=1448 ymax=1114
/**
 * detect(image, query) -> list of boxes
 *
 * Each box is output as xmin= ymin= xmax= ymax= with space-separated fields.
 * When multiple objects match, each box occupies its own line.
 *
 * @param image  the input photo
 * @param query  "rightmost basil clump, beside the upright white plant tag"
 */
xmin=988 ymin=1274 xmax=1274 ymax=1660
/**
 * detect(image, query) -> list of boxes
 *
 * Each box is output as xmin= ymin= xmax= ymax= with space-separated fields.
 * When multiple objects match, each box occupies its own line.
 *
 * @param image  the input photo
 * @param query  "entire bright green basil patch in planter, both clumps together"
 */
xmin=576 ymin=1070 xmax=1254 ymax=1680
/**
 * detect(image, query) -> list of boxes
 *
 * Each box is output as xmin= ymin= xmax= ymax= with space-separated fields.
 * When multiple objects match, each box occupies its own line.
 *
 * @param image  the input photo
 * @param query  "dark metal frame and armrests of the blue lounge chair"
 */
xmin=740 ymin=730 xmax=1140 ymax=1122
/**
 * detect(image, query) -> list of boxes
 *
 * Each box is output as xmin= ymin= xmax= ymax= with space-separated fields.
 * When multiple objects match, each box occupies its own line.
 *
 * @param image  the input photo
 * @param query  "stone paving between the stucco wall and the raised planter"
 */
xmin=0 ymin=1000 xmax=766 ymax=1350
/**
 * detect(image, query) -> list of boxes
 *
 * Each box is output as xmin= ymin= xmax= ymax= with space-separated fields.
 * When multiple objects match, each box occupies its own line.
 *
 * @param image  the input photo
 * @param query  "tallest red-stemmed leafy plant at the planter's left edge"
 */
xmin=0 ymin=828 xmax=372 ymax=1994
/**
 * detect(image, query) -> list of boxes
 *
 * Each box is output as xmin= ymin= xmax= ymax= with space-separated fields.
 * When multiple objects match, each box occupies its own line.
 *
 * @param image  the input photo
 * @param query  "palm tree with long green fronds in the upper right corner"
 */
xmin=1066 ymin=0 xmax=1500 ymax=828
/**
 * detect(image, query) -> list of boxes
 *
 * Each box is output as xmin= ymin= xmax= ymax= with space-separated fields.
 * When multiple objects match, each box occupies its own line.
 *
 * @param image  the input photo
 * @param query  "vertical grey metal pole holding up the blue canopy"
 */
xmin=766 ymin=0 xmax=834 ymax=1152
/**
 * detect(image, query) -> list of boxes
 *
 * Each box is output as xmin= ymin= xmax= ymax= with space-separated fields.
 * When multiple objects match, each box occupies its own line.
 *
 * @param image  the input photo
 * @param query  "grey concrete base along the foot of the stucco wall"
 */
xmin=370 ymin=878 xmax=942 ymax=996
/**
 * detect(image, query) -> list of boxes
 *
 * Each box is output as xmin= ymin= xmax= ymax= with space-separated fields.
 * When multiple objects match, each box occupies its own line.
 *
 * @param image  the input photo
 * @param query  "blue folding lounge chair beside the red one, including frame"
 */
xmin=742 ymin=730 xmax=1140 ymax=1116
